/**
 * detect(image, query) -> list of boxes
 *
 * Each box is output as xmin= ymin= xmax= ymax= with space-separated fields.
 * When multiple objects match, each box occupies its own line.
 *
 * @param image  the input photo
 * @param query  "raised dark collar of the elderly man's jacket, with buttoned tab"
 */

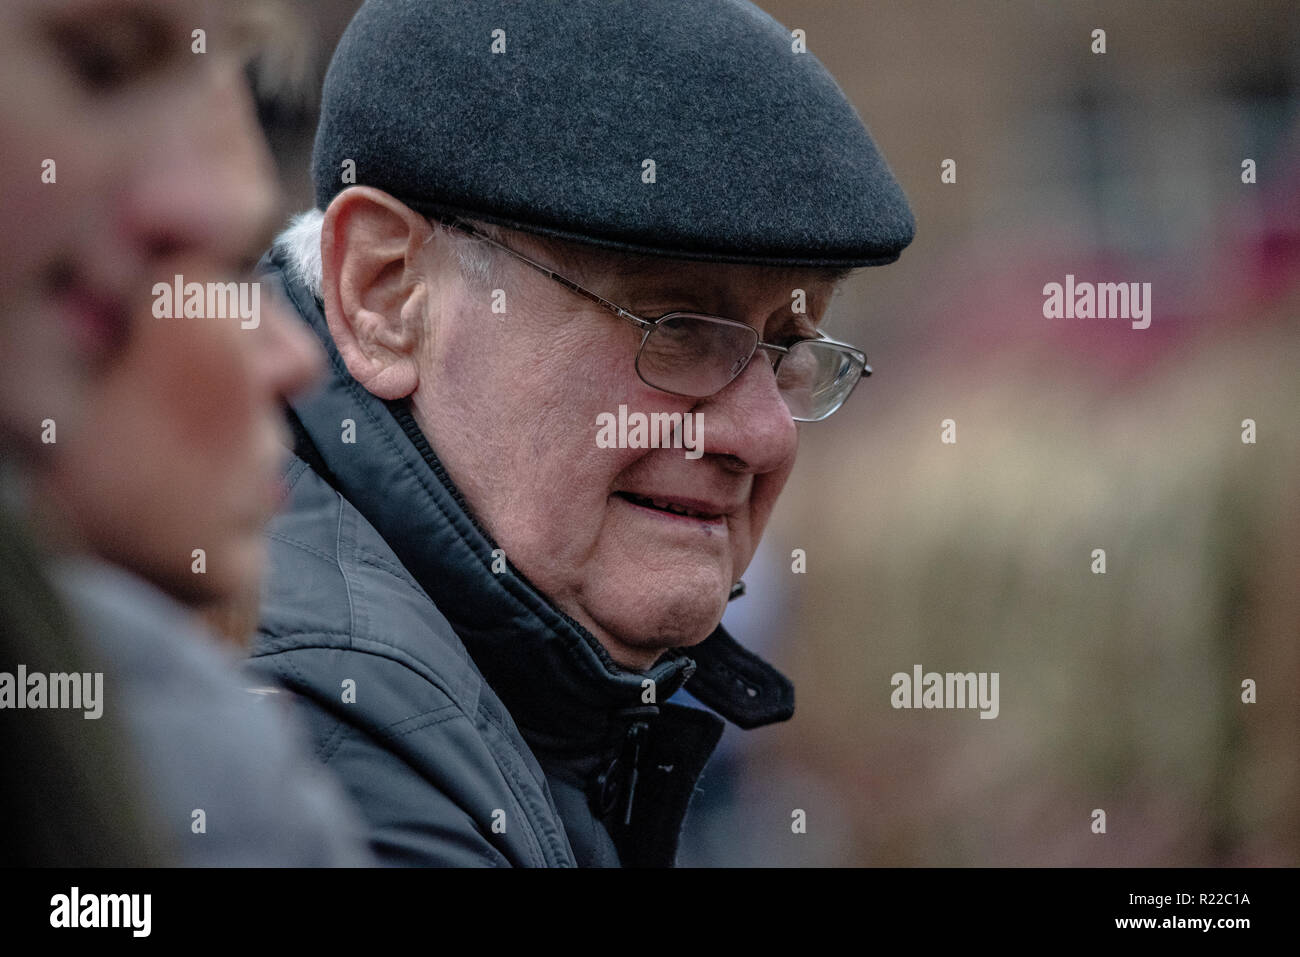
xmin=260 ymin=250 xmax=794 ymax=746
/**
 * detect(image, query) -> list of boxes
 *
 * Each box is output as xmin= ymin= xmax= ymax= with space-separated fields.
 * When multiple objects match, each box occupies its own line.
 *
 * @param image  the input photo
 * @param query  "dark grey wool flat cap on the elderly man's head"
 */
xmin=312 ymin=0 xmax=914 ymax=267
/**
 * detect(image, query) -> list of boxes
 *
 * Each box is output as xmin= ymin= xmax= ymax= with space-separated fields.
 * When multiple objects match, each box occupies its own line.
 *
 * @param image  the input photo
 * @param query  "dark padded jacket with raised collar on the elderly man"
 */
xmin=251 ymin=251 xmax=787 ymax=866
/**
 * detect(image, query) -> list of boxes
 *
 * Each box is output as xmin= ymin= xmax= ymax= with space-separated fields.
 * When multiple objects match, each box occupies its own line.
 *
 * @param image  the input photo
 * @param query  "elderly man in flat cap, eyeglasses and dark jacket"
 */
xmin=245 ymin=0 xmax=913 ymax=866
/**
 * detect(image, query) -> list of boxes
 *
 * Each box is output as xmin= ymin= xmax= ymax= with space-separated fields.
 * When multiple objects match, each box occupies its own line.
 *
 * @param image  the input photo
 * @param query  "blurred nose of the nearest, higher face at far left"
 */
xmin=117 ymin=60 xmax=277 ymax=268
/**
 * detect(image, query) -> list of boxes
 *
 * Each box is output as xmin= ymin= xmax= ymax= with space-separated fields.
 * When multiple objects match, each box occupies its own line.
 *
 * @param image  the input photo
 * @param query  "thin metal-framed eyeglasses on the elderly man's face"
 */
xmin=434 ymin=216 xmax=871 ymax=423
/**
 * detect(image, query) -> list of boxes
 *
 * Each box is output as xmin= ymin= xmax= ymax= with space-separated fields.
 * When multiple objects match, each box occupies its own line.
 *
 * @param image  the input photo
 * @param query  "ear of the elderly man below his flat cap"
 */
xmin=321 ymin=186 xmax=433 ymax=399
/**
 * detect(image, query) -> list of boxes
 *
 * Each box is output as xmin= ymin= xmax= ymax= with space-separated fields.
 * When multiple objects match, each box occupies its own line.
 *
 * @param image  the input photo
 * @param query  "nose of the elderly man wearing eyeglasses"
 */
xmin=694 ymin=350 xmax=798 ymax=475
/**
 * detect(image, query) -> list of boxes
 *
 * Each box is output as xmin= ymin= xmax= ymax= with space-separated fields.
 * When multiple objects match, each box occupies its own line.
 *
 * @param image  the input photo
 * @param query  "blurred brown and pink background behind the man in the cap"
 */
xmin=256 ymin=0 xmax=1300 ymax=866
